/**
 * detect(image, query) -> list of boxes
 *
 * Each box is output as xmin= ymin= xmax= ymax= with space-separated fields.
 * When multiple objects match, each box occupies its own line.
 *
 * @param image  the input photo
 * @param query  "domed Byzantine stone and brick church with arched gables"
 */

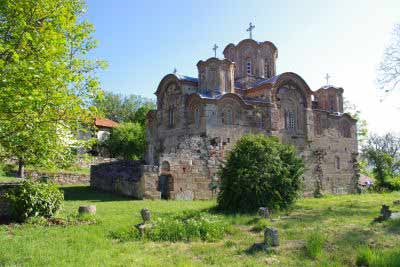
xmin=142 ymin=34 xmax=358 ymax=199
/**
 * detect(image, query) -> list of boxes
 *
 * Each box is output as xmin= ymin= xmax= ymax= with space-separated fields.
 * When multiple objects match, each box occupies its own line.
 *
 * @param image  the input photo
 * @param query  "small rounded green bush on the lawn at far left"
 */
xmin=5 ymin=181 xmax=64 ymax=222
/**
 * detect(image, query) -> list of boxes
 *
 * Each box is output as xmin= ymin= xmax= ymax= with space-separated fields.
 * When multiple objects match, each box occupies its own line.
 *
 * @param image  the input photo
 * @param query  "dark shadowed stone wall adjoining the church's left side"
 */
xmin=90 ymin=160 xmax=145 ymax=199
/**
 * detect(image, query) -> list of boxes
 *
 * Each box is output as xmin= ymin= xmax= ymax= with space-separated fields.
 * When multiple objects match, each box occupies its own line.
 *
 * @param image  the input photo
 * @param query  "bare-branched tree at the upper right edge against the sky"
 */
xmin=378 ymin=24 xmax=400 ymax=92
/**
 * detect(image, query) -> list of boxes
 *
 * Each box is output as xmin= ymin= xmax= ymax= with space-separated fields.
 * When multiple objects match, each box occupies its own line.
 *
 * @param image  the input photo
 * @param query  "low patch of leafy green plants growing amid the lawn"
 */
xmin=110 ymin=212 xmax=230 ymax=242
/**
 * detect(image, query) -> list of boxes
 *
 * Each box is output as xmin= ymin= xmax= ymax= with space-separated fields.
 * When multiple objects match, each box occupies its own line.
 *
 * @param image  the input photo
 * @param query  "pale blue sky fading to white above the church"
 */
xmin=86 ymin=0 xmax=400 ymax=134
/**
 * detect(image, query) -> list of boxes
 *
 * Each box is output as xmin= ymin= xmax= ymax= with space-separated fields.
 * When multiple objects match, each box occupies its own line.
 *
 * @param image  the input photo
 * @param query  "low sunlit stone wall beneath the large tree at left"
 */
xmin=25 ymin=170 xmax=90 ymax=185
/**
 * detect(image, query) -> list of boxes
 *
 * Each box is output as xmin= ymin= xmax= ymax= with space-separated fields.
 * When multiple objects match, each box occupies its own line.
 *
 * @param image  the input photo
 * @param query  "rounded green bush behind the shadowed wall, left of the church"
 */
xmin=102 ymin=122 xmax=146 ymax=160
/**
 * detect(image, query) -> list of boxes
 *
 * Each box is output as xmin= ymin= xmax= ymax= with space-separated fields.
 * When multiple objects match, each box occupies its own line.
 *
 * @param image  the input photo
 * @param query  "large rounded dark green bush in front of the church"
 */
xmin=218 ymin=135 xmax=304 ymax=212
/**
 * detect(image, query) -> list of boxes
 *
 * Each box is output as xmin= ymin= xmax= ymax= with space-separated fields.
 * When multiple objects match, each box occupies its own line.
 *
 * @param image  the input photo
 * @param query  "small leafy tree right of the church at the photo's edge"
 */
xmin=362 ymin=133 xmax=400 ymax=190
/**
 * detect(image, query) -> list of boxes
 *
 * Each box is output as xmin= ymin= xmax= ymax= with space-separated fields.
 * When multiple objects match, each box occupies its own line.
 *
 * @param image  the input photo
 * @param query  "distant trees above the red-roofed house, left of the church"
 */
xmin=93 ymin=92 xmax=155 ymax=125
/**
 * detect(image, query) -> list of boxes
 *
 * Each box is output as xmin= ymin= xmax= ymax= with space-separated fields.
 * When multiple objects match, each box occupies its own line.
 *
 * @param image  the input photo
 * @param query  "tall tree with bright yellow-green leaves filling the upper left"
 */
xmin=0 ymin=0 xmax=105 ymax=176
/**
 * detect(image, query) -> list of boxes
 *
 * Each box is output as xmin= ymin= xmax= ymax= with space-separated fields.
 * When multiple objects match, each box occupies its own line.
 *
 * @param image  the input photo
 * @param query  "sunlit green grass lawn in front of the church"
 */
xmin=0 ymin=186 xmax=400 ymax=266
